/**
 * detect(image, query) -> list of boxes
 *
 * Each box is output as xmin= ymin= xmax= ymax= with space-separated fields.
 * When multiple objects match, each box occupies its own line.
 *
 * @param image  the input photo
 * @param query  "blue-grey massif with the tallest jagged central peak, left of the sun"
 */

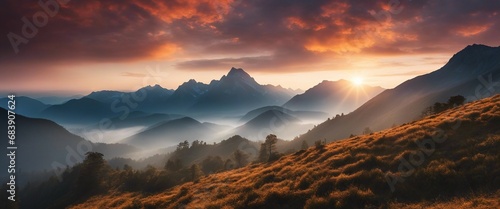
xmin=86 ymin=68 xmax=295 ymax=115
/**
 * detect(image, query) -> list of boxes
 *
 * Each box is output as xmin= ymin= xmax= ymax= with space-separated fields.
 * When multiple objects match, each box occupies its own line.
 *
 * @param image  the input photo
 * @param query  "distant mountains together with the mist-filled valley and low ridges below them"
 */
xmin=1 ymin=68 xmax=381 ymax=148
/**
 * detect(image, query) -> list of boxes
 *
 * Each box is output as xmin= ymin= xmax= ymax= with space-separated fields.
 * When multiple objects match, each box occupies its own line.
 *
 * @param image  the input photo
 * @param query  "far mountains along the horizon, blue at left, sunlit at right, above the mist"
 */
xmin=2 ymin=68 xmax=382 ymax=129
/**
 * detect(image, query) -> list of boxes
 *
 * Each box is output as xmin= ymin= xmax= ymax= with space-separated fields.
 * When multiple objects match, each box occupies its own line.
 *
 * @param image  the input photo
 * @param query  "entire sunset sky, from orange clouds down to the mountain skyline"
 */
xmin=0 ymin=0 xmax=500 ymax=95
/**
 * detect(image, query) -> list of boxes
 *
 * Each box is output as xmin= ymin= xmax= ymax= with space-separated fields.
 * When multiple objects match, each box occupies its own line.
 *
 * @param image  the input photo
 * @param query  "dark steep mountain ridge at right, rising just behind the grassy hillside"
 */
xmin=296 ymin=44 xmax=500 ymax=144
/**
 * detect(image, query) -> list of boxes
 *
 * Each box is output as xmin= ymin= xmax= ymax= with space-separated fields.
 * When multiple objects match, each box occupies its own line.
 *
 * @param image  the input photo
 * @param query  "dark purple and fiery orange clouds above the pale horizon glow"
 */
xmin=0 ymin=0 xmax=500 ymax=91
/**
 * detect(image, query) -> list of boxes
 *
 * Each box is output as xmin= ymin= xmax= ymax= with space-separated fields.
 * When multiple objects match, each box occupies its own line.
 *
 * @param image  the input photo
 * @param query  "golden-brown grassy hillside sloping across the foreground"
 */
xmin=72 ymin=95 xmax=500 ymax=209
